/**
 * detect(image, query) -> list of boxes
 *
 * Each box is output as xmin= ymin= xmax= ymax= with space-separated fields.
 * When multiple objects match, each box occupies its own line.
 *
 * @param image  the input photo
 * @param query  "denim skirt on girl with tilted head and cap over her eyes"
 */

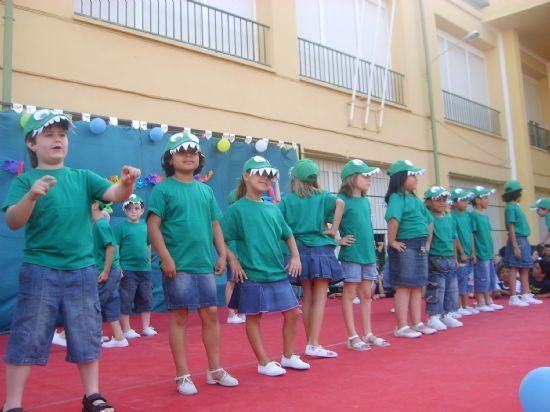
xmin=228 ymin=279 xmax=298 ymax=315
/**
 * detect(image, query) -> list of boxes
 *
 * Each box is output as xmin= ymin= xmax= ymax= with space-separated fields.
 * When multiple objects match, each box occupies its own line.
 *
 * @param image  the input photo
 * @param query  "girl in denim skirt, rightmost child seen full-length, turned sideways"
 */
xmin=502 ymin=180 xmax=542 ymax=306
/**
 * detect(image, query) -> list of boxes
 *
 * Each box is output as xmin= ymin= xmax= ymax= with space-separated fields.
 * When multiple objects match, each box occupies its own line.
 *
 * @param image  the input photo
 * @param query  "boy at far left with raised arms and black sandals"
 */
xmin=2 ymin=109 xmax=140 ymax=412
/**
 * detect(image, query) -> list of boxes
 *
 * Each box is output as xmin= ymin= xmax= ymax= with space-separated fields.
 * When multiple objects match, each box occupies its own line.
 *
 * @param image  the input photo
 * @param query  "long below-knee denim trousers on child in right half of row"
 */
xmin=426 ymin=256 xmax=458 ymax=315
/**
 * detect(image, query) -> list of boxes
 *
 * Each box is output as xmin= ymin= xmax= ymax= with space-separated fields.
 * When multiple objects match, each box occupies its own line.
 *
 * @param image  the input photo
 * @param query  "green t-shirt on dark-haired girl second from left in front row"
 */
xmin=147 ymin=177 xmax=222 ymax=274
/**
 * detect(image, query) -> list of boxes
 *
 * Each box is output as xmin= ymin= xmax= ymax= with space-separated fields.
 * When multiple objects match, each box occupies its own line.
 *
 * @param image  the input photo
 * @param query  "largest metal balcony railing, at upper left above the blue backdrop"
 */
xmin=74 ymin=0 xmax=269 ymax=65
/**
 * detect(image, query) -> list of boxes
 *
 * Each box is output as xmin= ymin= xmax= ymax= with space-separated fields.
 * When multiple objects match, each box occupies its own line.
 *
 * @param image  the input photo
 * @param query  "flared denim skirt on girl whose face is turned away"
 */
xmin=285 ymin=244 xmax=344 ymax=286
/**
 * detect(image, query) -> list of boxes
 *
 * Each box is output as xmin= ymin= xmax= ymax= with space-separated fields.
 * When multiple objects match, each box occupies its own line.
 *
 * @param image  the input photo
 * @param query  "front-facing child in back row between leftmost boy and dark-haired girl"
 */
xmin=114 ymin=194 xmax=157 ymax=339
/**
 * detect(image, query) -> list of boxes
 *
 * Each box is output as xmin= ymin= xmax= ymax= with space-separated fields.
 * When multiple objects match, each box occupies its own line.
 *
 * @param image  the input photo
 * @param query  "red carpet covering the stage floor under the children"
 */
xmin=0 ymin=299 xmax=550 ymax=412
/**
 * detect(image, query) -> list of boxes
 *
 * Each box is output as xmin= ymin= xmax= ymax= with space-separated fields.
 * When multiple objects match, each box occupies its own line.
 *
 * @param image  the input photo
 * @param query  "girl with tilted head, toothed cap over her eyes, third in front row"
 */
xmin=222 ymin=156 xmax=309 ymax=376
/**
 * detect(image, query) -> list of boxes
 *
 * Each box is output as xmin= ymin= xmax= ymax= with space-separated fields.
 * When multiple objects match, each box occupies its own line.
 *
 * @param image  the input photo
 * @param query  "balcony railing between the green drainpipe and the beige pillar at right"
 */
xmin=442 ymin=90 xmax=500 ymax=135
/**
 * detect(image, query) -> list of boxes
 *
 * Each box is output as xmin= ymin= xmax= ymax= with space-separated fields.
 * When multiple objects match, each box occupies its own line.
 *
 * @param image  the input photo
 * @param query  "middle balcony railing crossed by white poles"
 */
xmin=298 ymin=38 xmax=405 ymax=105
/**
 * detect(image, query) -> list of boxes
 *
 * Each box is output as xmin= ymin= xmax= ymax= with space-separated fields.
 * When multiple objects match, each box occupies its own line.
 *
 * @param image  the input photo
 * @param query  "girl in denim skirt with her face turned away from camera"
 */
xmin=278 ymin=159 xmax=344 ymax=358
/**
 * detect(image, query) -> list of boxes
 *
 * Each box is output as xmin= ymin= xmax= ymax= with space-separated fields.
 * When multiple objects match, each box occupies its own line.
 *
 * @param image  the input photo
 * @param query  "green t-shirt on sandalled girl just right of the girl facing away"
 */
xmin=338 ymin=193 xmax=376 ymax=265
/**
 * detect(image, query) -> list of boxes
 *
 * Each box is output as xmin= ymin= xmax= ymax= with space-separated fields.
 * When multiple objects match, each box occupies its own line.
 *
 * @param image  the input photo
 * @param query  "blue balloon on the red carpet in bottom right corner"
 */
xmin=519 ymin=366 xmax=550 ymax=412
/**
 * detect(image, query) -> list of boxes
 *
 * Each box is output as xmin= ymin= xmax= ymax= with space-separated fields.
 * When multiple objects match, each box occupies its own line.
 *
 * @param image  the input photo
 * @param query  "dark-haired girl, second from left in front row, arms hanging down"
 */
xmin=147 ymin=132 xmax=239 ymax=395
